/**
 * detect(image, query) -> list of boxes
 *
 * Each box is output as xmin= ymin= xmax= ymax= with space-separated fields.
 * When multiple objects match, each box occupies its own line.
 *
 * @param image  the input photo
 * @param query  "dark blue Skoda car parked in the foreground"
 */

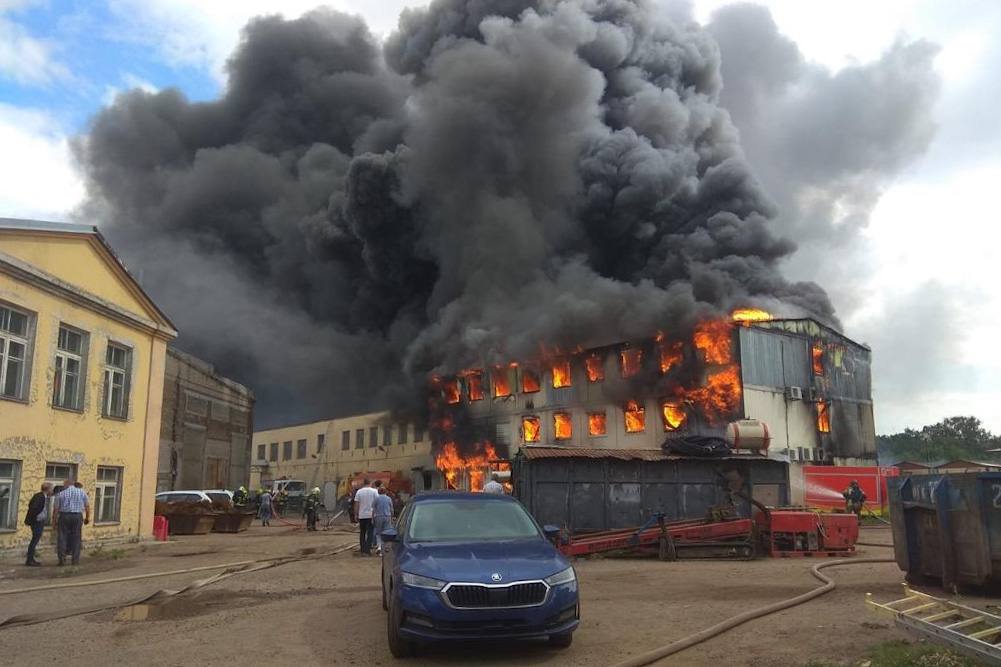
xmin=382 ymin=492 xmax=581 ymax=658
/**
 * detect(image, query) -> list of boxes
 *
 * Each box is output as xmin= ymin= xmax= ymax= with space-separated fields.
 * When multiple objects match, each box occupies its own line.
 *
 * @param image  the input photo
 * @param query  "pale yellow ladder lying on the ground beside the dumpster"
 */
xmin=866 ymin=584 xmax=1001 ymax=666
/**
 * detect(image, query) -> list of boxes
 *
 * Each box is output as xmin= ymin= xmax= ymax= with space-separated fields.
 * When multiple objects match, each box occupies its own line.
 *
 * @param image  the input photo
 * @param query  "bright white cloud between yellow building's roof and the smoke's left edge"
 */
xmin=0 ymin=104 xmax=84 ymax=219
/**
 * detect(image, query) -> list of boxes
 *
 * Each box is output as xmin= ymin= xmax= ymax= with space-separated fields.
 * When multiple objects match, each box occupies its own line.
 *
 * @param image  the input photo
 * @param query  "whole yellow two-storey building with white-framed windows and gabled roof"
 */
xmin=0 ymin=218 xmax=177 ymax=550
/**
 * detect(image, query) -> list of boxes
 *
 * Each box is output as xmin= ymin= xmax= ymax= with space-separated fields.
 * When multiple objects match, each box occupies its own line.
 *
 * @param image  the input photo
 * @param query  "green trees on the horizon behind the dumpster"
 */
xmin=876 ymin=417 xmax=1001 ymax=464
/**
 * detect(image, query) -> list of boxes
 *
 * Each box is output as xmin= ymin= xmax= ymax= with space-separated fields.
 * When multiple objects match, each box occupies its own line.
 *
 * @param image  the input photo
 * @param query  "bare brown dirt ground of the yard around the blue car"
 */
xmin=0 ymin=526 xmax=960 ymax=667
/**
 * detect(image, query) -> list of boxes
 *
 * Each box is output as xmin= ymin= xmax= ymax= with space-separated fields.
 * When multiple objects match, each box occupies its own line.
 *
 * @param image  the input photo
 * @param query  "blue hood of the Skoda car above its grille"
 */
xmin=399 ymin=539 xmax=570 ymax=584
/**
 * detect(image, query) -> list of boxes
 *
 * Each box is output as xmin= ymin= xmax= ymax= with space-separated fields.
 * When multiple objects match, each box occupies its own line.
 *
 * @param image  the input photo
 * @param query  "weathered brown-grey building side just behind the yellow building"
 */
xmin=156 ymin=348 xmax=254 ymax=491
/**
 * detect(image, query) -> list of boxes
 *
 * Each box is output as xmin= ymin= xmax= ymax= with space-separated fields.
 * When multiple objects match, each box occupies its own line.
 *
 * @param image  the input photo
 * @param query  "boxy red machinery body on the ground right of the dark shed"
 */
xmin=755 ymin=510 xmax=859 ymax=558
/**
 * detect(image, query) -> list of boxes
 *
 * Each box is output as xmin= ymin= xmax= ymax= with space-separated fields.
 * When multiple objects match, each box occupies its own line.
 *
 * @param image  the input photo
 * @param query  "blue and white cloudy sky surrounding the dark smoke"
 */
xmin=0 ymin=0 xmax=1001 ymax=433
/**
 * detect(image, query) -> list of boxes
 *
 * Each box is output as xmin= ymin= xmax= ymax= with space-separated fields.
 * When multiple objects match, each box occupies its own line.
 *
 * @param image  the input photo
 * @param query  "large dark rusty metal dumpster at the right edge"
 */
xmin=888 ymin=466 xmax=1001 ymax=589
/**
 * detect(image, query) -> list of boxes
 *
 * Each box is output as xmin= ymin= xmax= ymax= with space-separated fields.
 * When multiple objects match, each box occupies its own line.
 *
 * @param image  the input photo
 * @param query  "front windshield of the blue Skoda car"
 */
xmin=407 ymin=499 xmax=540 ymax=542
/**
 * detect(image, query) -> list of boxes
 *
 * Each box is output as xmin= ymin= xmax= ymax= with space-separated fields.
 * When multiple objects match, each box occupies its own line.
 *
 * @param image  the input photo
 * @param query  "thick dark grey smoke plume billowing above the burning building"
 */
xmin=77 ymin=0 xmax=932 ymax=424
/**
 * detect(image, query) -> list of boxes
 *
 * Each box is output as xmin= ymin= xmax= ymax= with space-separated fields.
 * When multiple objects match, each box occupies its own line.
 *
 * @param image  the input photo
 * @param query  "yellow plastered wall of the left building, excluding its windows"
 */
xmin=0 ymin=229 xmax=174 ymax=550
